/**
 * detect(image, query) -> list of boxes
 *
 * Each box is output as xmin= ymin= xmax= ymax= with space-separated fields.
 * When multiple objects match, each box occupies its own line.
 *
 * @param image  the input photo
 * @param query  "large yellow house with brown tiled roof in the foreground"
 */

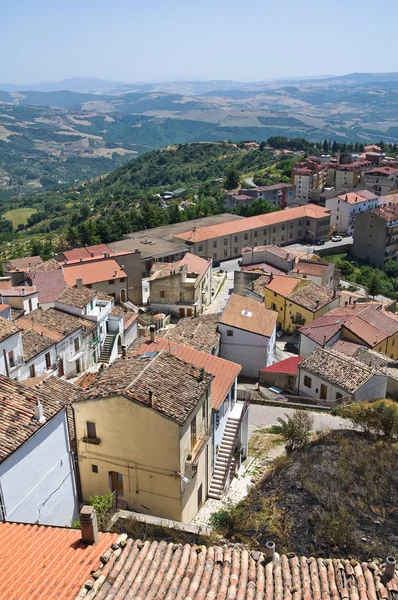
xmin=73 ymin=351 xmax=213 ymax=523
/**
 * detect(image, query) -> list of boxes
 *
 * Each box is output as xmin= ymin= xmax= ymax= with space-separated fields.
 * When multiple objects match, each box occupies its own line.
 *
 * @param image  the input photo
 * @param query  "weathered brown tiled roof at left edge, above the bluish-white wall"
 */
xmin=0 ymin=375 xmax=69 ymax=462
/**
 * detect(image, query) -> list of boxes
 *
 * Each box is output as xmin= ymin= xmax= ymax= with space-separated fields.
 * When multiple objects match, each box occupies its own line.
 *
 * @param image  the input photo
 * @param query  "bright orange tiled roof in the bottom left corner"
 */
xmin=0 ymin=523 xmax=118 ymax=600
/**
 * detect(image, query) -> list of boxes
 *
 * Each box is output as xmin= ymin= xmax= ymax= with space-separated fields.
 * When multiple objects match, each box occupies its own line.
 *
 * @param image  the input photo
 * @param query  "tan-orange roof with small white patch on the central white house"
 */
xmin=220 ymin=294 xmax=278 ymax=337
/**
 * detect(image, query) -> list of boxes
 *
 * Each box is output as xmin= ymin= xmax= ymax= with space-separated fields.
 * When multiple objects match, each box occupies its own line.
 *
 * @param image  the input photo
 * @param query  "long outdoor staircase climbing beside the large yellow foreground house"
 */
xmin=208 ymin=416 xmax=241 ymax=500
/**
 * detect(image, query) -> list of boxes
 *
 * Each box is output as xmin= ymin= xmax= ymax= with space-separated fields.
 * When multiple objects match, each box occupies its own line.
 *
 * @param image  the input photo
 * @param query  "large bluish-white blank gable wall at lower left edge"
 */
xmin=0 ymin=410 xmax=78 ymax=526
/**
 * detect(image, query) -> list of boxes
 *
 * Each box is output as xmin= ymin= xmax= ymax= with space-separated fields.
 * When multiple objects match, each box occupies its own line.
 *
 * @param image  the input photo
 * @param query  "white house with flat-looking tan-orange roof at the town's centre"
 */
xmin=218 ymin=294 xmax=278 ymax=378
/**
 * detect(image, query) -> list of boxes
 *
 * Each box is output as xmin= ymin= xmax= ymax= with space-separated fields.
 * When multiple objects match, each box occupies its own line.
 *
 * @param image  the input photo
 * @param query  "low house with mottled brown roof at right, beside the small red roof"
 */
xmin=298 ymin=348 xmax=387 ymax=404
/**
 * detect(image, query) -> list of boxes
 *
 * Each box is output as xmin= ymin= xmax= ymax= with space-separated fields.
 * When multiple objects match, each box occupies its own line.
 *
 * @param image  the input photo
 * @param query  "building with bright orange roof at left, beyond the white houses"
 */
xmin=63 ymin=258 xmax=129 ymax=302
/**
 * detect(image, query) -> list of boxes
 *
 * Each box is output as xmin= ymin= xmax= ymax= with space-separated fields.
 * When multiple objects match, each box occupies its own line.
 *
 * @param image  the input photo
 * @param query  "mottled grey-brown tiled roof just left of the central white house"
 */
xmin=164 ymin=313 xmax=221 ymax=352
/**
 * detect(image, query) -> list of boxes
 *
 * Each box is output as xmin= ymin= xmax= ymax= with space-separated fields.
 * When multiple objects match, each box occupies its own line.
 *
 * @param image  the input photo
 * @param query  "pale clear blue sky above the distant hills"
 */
xmin=0 ymin=0 xmax=398 ymax=84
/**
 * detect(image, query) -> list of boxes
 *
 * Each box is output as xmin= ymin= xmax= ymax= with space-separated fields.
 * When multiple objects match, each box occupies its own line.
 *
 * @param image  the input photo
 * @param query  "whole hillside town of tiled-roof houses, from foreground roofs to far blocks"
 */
xmin=0 ymin=145 xmax=398 ymax=600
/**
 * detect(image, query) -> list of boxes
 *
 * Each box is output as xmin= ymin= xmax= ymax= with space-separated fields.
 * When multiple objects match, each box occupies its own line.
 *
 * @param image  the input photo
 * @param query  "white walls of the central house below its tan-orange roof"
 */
xmin=218 ymin=323 xmax=276 ymax=378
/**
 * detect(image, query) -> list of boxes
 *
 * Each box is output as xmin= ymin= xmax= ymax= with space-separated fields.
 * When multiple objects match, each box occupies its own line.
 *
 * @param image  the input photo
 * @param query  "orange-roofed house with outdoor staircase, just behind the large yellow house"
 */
xmin=130 ymin=332 xmax=248 ymax=499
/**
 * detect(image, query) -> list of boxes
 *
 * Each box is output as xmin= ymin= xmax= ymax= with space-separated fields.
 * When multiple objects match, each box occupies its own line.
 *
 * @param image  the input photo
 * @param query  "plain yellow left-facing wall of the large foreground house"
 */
xmin=73 ymin=397 xmax=185 ymax=521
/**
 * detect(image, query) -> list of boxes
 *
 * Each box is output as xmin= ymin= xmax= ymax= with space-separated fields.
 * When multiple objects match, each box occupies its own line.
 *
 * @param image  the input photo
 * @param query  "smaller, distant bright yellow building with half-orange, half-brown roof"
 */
xmin=264 ymin=275 xmax=339 ymax=333
